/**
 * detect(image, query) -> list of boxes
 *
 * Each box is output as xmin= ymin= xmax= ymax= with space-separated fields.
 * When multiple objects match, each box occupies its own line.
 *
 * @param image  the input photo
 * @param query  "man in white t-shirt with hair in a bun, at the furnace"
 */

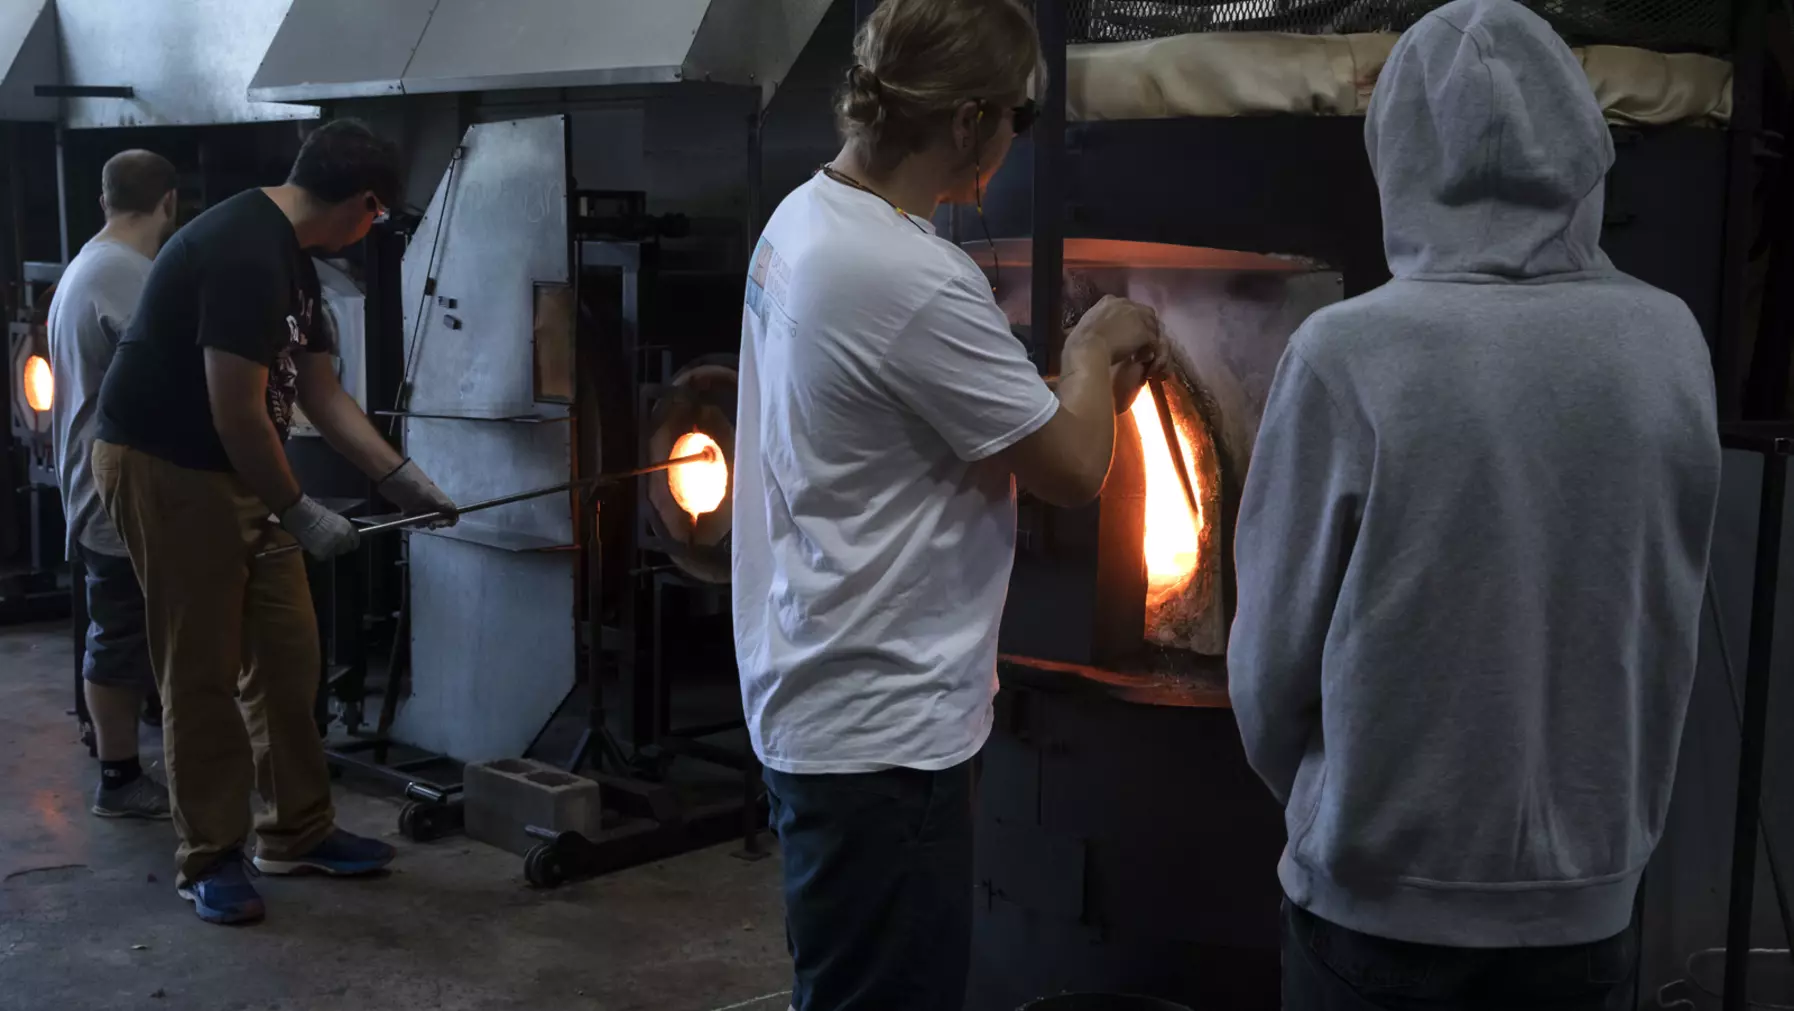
xmin=734 ymin=0 xmax=1163 ymax=1011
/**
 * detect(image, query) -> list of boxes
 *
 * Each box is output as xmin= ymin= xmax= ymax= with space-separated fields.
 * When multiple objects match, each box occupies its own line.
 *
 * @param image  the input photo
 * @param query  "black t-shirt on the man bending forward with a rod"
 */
xmin=99 ymin=190 xmax=335 ymax=471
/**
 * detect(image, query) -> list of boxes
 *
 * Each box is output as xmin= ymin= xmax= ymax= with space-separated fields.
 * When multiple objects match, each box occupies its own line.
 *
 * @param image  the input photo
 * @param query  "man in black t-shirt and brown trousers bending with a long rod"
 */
xmin=93 ymin=120 xmax=456 ymax=923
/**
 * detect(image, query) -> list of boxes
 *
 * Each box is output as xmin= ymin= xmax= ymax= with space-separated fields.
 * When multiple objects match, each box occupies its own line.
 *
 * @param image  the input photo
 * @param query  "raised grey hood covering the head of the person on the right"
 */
xmin=1363 ymin=0 xmax=1613 ymax=278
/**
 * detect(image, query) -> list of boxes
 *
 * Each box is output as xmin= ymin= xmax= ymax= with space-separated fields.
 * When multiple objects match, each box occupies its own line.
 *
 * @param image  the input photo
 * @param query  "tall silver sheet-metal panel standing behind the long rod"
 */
xmin=395 ymin=117 xmax=576 ymax=762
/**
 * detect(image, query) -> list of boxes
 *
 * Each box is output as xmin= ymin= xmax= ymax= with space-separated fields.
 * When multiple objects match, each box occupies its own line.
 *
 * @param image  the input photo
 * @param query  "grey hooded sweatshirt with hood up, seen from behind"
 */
xmin=1227 ymin=0 xmax=1720 ymax=948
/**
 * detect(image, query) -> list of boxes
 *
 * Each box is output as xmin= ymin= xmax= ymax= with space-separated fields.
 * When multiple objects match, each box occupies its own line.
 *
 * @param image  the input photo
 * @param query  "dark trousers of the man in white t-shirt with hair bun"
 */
xmin=766 ymin=762 xmax=972 ymax=1011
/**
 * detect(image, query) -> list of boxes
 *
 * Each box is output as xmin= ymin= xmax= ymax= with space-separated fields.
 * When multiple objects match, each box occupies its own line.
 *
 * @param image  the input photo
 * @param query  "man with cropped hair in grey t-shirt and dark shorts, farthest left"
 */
xmin=48 ymin=151 xmax=176 ymax=819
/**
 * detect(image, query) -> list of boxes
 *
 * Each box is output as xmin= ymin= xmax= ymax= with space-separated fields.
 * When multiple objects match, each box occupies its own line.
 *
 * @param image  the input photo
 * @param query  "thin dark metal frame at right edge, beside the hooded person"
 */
xmin=1720 ymin=425 xmax=1794 ymax=1011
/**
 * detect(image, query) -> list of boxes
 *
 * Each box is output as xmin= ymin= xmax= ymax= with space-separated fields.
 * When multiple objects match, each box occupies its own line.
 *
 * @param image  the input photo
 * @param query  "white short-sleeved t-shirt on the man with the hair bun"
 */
xmin=734 ymin=176 xmax=1058 ymax=774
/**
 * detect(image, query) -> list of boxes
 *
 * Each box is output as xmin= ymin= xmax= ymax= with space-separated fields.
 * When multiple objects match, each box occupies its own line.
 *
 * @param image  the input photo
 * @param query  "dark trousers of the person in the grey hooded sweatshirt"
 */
xmin=1283 ymin=900 xmax=1638 ymax=1011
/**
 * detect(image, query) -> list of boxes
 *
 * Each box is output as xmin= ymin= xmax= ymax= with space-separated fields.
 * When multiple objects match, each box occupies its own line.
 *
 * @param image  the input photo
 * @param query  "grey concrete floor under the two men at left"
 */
xmin=0 ymin=626 xmax=789 ymax=1011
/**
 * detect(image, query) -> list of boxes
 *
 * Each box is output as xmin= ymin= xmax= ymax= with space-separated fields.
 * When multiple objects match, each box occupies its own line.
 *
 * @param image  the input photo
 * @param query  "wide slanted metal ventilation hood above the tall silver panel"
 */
xmin=249 ymin=0 xmax=829 ymax=102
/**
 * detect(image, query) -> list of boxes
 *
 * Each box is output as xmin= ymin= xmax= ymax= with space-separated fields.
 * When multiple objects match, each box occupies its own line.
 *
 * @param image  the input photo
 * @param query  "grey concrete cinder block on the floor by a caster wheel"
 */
xmin=461 ymin=758 xmax=605 ymax=857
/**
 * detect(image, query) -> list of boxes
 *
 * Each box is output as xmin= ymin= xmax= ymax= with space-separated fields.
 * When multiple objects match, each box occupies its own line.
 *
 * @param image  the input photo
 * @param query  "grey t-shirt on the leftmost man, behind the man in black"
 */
xmin=48 ymin=238 xmax=151 ymax=556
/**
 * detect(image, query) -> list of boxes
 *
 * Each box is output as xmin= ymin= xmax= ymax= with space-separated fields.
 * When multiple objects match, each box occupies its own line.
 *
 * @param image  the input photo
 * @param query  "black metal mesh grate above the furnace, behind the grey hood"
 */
xmin=1069 ymin=0 xmax=1731 ymax=52
